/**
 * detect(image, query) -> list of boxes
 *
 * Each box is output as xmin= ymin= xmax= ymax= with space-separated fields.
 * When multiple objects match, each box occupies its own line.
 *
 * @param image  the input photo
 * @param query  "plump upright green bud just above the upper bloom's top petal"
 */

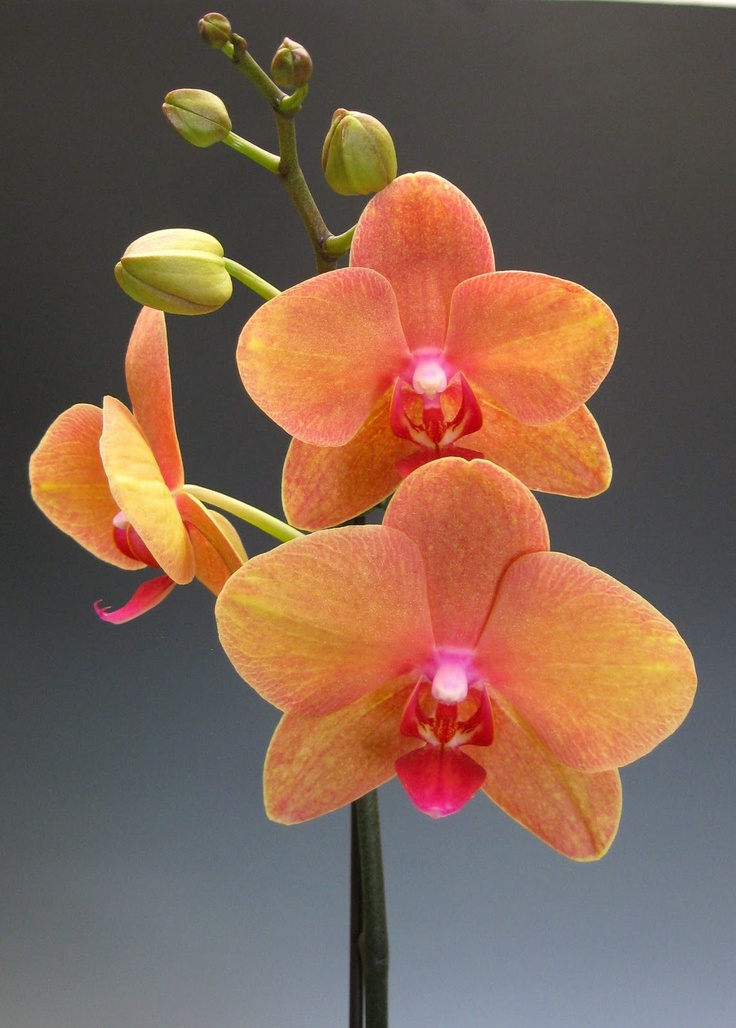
xmin=322 ymin=107 xmax=397 ymax=196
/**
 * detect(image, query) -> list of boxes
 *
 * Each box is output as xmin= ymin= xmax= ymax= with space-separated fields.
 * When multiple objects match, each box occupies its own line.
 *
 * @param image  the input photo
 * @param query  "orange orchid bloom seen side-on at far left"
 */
xmin=30 ymin=307 xmax=246 ymax=624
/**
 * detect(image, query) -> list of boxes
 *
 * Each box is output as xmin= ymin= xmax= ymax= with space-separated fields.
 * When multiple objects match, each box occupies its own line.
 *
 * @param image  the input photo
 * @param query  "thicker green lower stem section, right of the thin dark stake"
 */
xmin=354 ymin=791 xmax=389 ymax=1028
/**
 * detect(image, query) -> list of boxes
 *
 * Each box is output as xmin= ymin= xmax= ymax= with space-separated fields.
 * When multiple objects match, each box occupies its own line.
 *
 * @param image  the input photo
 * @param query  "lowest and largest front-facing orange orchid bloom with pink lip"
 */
xmin=216 ymin=457 xmax=696 ymax=860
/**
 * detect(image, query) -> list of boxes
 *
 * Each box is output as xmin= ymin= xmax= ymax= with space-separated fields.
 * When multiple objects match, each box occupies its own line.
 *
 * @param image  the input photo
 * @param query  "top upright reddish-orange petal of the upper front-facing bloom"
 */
xmin=351 ymin=172 xmax=493 ymax=353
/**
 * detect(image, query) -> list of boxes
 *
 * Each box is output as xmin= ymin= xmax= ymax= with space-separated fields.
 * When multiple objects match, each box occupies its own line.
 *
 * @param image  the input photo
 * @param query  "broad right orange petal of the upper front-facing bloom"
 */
xmin=444 ymin=271 xmax=618 ymax=425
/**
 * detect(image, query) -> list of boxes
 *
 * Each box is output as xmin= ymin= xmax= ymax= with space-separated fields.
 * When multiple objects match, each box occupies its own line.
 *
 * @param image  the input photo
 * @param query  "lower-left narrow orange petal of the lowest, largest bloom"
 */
xmin=263 ymin=674 xmax=417 ymax=824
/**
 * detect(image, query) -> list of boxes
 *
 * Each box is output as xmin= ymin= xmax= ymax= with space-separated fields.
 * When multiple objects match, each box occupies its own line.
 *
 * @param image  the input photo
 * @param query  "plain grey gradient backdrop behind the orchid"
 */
xmin=0 ymin=0 xmax=736 ymax=1028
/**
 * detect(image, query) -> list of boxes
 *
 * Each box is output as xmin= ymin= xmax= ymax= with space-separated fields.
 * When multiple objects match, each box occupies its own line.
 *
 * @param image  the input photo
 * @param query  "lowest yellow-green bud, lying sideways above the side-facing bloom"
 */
xmin=115 ymin=228 xmax=232 ymax=315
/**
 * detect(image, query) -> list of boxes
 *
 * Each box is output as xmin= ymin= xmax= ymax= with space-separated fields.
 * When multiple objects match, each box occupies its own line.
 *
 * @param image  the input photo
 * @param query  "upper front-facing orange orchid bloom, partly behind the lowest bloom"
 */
xmin=237 ymin=172 xmax=618 ymax=529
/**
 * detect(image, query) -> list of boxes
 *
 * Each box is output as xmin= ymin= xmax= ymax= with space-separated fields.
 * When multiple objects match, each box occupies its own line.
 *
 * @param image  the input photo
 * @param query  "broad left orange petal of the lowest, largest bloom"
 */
xmin=216 ymin=525 xmax=433 ymax=717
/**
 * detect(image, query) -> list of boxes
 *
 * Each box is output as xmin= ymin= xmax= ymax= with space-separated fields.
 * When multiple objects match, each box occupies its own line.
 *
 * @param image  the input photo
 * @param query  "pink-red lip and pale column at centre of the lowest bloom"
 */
xmin=395 ymin=656 xmax=493 ymax=817
